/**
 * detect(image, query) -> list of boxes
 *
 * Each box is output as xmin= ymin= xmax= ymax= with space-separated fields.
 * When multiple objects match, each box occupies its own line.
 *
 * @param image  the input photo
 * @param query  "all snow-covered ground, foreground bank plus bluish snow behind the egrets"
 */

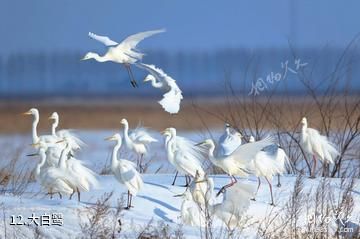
xmin=0 ymin=131 xmax=360 ymax=238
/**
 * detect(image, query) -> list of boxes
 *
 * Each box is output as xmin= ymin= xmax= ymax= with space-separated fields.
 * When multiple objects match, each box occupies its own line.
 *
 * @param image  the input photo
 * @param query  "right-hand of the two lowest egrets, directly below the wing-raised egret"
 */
xmin=209 ymin=182 xmax=255 ymax=230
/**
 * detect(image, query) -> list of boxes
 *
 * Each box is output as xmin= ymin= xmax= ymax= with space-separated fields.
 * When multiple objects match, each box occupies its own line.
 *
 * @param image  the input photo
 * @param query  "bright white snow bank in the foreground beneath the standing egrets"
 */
xmin=0 ymin=174 xmax=360 ymax=238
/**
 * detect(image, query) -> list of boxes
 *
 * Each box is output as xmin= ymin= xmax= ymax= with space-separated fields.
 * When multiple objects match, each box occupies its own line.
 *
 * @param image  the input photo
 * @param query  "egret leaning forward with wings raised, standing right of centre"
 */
xmin=197 ymin=137 xmax=273 ymax=196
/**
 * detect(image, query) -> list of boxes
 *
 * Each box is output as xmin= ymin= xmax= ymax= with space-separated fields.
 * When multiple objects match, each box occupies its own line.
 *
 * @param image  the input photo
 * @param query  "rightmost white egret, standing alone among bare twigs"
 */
xmin=300 ymin=117 xmax=340 ymax=178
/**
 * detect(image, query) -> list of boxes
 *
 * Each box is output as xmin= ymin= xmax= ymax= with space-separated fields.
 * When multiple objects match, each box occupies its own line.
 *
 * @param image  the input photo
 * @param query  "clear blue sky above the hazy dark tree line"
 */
xmin=0 ymin=0 xmax=360 ymax=55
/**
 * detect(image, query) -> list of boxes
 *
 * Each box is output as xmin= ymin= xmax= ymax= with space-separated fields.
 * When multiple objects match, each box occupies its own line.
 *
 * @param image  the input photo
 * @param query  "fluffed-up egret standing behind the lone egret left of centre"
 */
xmin=120 ymin=119 xmax=157 ymax=173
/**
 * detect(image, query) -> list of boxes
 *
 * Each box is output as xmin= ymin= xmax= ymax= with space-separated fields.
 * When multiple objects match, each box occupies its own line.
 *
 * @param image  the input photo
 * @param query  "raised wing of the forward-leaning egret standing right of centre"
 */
xmin=230 ymin=136 xmax=274 ymax=162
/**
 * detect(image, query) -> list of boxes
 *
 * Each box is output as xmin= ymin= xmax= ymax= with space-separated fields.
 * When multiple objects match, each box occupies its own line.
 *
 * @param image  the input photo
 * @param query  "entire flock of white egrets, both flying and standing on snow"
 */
xmin=19 ymin=30 xmax=339 ymax=226
